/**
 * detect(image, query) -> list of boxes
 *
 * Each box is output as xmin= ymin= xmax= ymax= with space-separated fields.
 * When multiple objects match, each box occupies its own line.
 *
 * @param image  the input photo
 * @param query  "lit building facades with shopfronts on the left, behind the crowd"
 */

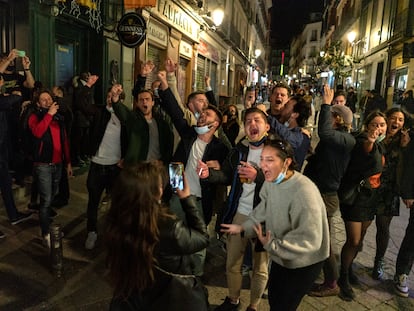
xmin=0 ymin=0 xmax=271 ymax=108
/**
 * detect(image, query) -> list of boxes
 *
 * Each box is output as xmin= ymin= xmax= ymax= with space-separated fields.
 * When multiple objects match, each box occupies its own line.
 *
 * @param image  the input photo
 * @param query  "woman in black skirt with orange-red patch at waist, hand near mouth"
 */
xmin=338 ymin=111 xmax=387 ymax=301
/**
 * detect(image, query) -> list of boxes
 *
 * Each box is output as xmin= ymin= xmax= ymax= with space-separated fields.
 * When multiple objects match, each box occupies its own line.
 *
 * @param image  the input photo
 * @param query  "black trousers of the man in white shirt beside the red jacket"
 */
xmin=86 ymin=162 xmax=121 ymax=232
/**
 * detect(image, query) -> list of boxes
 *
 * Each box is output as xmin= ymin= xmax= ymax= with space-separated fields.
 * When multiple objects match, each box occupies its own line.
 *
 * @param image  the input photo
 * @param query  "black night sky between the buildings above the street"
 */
xmin=271 ymin=0 xmax=324 ymax=47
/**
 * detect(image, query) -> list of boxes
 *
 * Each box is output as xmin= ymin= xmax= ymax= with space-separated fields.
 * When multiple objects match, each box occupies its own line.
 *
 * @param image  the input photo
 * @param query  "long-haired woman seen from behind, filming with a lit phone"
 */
xmin=106 ymin=162 xmax=209 ymax=311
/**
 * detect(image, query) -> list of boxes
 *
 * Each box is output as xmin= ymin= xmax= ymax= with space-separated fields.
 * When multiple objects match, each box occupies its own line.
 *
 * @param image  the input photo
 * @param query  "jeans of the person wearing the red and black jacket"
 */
xmin=33 ymin=163 xmax=62 ymax=235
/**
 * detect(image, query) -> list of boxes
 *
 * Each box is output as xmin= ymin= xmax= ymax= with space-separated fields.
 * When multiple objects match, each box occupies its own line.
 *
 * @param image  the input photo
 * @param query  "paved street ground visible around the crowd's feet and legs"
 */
xmin=0 ymin=174 xmax=414 ymax=311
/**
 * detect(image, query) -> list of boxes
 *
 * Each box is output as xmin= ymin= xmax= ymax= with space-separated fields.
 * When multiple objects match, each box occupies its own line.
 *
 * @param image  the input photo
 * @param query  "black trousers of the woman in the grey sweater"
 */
xmin=268 ymin=261 xmax=324 ymax=311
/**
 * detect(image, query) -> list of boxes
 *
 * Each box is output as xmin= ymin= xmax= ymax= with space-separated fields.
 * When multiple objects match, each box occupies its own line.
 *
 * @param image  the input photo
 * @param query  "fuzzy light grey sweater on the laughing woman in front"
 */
xmin=242 ymin=171 xmax=329 ymax=269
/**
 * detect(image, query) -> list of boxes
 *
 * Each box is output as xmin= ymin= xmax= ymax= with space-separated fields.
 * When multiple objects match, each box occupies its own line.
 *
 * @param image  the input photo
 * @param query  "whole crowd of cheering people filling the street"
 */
xmin=0 ymin=50 xmax=414 ymax=311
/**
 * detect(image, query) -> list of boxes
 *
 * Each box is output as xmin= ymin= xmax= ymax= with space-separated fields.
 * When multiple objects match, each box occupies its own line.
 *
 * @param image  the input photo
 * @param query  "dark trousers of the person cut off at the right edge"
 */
xmin=395 ymin=207 xmax=414 ymax=275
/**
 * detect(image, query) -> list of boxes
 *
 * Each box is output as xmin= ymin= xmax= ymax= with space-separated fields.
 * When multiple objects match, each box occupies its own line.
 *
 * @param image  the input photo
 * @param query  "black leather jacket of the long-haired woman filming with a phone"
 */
xmin=110 ymin=196 xmax=209 ymax=311
